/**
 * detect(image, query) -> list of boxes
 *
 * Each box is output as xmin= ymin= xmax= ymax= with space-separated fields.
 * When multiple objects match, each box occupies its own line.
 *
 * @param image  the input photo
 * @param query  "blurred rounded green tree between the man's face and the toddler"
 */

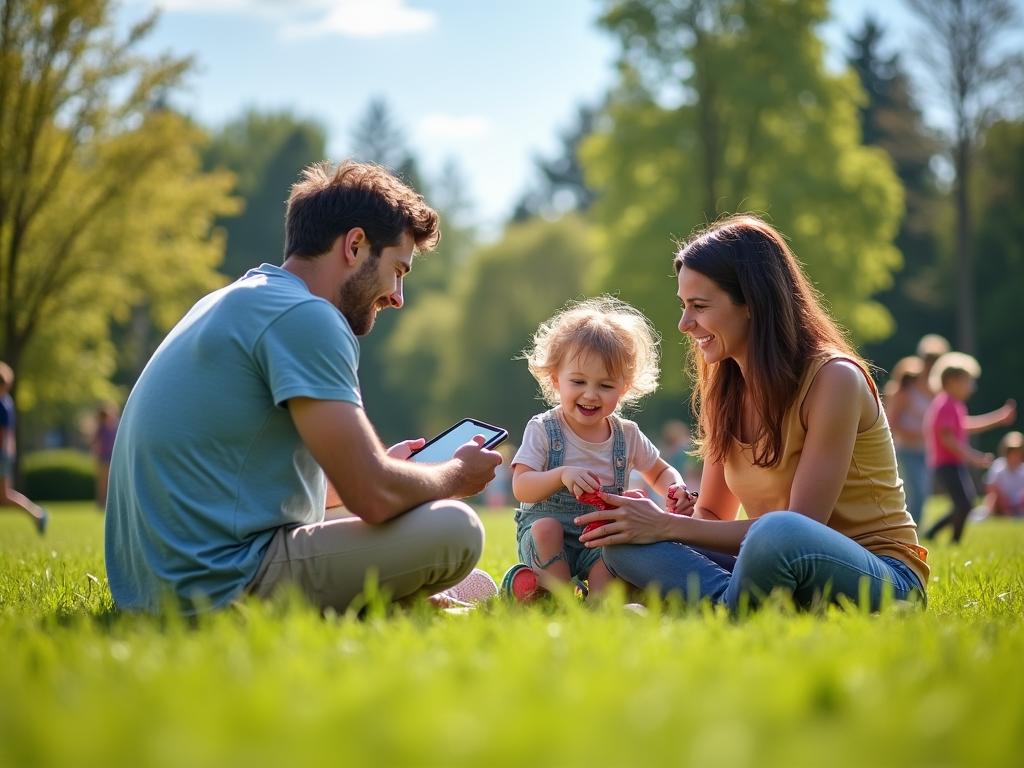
xmin=387 ymin=216 xmax=595 ymax=441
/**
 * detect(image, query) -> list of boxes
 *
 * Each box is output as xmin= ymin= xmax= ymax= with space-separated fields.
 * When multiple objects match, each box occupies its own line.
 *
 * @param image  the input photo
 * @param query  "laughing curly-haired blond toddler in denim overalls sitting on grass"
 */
xmin=505 ymin=296 xmax=685 ymax=599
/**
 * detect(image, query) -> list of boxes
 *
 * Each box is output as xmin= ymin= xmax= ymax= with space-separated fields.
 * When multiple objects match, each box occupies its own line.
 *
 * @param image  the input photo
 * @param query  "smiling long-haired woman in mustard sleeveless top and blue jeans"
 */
xmin=577 ymin=215 xmax=929 ymax=611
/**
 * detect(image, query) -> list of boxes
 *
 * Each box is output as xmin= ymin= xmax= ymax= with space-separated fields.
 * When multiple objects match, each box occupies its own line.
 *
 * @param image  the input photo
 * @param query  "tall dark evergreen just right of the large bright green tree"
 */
xmin=847 ymin=17 xmax=953 ymax=370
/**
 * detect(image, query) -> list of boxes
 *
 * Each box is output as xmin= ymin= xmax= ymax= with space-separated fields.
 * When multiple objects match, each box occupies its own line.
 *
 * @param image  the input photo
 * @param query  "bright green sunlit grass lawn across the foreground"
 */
xmin=0 ymin=504 xmax=1024 ymax=767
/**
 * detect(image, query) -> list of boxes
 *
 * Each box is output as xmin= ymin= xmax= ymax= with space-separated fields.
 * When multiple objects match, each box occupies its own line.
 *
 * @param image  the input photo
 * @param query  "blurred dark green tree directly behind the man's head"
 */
xmin=203 ymin=111 xmax=327 ymax=280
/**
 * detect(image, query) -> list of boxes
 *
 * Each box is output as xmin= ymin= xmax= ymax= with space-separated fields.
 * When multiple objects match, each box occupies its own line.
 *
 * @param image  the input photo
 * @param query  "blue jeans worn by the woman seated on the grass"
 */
xmin=604 ymin=512 xmax=925 ymax=612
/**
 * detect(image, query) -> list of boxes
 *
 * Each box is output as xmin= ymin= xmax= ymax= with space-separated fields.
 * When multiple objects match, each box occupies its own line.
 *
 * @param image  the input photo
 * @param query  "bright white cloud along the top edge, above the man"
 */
xmin=136 ymin=0 xmax=437 ymax=38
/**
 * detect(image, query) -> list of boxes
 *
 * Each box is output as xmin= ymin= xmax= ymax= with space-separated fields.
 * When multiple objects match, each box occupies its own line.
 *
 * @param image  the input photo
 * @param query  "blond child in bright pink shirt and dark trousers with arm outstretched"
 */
xmin=924 ymin=352 xmax=1017 ymax=544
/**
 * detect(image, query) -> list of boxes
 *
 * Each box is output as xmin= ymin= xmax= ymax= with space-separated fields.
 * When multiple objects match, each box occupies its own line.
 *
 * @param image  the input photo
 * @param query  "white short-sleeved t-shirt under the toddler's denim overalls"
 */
xmin=511 ymin=406 xmax=659 ymax=485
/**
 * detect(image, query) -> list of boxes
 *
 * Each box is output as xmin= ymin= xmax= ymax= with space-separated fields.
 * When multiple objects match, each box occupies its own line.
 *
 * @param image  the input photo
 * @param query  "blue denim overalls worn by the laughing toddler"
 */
xmin=515 ymin=414 xmax=626 ymax=580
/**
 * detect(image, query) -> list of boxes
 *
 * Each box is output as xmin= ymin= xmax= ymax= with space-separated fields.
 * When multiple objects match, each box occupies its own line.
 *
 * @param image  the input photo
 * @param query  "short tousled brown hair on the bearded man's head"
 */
xmin=285 ymin=160 xmax=441 ymax=259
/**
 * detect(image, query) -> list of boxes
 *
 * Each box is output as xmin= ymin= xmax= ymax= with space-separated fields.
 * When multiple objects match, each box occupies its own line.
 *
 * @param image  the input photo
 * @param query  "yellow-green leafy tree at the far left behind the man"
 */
xmin=0 ymin=0 xmax=234 ymax=434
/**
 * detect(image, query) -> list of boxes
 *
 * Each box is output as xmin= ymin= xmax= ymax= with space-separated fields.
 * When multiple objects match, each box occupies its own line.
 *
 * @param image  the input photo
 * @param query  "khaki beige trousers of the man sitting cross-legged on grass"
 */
xmin=246 ymin=500 xmax=483 ymax=612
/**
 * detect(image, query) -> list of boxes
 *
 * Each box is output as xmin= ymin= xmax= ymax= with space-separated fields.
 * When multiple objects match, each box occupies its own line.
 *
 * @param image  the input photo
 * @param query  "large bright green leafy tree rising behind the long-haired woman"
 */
xmin=581 ymin=0 xmax=902 ymax=397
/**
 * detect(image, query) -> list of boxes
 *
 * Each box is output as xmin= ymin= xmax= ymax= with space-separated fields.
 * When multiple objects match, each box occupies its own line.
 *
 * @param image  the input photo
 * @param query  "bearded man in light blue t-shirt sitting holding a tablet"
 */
xmin=106 ymin=161 xmax=501 ymax=613
